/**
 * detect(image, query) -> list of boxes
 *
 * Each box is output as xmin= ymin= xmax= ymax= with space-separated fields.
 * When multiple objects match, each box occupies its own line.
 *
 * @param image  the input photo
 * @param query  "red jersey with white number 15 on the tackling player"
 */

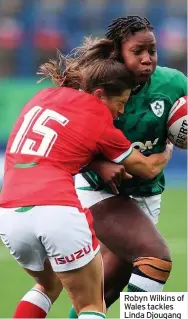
xmin=0 ymin=88 xmax=132 ymax=208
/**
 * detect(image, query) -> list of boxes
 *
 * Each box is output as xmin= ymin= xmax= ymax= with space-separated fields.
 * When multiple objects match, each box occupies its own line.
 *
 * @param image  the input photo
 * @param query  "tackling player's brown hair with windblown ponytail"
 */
xmin=38 ymin=38 xmax=135 ymax=96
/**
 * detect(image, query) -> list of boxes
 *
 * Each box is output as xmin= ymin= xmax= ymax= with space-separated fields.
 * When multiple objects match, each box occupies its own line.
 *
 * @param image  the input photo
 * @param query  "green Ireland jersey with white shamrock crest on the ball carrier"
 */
xmin=84 ymin=66 xmax=187 ymax=197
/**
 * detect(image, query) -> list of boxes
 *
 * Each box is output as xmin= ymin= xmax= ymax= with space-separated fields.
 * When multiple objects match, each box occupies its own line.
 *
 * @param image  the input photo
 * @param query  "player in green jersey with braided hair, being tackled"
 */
xmin=70 ymin=16 xmax=187 ymax=318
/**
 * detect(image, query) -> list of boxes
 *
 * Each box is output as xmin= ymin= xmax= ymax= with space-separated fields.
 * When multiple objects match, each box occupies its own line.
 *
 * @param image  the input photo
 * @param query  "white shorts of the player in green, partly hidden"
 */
xmin=75 ymin=174 xmax=161 ymax=225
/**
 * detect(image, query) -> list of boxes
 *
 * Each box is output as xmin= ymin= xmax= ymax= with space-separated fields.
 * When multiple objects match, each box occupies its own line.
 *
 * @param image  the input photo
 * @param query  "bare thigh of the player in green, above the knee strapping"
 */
xmin=90 ymin=196 xmax=168 ymax=262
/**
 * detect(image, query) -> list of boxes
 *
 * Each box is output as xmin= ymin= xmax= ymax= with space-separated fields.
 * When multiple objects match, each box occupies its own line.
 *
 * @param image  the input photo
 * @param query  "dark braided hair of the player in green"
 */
xmin=105 ymin=16 xmax=153 ymax=61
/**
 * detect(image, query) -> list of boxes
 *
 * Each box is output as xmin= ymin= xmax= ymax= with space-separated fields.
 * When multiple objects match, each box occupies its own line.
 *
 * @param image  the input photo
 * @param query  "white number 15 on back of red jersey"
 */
xmin=10 ymin=106 xmax=69 ymax=157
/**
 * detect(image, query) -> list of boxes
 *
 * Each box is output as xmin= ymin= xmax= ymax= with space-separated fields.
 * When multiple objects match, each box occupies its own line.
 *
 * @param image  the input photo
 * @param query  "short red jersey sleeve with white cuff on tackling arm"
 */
xmin=97 ymin=124 xmax=133 ymax=163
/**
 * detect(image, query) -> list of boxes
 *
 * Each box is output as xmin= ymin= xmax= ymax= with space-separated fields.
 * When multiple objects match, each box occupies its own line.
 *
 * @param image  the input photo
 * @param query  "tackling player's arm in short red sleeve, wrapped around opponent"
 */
xmin=97 ymin=118 xmax=172 ymax=179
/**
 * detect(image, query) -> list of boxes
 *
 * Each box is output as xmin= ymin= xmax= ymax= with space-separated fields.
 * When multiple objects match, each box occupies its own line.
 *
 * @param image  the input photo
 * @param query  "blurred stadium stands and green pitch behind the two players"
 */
xmin=0 ymin=0 xmax=187 ymax=318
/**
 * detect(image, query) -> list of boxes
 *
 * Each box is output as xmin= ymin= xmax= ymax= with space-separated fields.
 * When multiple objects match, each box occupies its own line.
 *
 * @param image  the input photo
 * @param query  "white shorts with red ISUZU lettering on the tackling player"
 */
xmin=0 ymin=206 xmax=99 ymax=272
